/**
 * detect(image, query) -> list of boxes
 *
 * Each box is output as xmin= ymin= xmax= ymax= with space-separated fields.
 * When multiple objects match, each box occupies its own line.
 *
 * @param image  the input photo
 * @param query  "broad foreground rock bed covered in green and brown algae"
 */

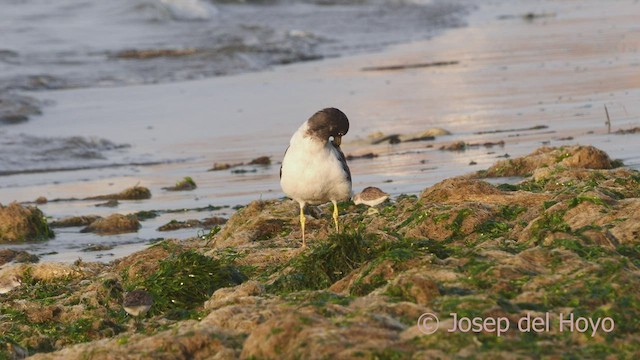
xmin=7 ymin=148 xmax=640 ymax=359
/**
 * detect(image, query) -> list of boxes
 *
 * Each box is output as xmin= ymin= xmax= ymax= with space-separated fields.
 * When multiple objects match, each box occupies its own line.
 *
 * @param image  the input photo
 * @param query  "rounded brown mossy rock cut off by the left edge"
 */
xmin=0 ymin=202 xmax=54 ymax=242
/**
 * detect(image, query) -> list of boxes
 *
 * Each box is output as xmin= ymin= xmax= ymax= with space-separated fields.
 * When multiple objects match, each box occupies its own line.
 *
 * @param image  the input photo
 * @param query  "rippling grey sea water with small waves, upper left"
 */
xmin=0 ymin=0 xmax=475 ymax=175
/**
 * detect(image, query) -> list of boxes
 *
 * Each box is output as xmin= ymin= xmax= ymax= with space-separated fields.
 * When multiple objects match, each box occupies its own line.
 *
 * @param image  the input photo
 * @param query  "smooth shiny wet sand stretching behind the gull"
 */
xmin=0 ymin=0 xmax=640 ymax=261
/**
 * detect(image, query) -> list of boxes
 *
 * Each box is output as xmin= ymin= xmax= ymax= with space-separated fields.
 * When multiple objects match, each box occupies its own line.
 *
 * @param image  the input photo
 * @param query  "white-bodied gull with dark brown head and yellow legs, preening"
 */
xmin=280 ymin=108 xmax=351 ymax=247
